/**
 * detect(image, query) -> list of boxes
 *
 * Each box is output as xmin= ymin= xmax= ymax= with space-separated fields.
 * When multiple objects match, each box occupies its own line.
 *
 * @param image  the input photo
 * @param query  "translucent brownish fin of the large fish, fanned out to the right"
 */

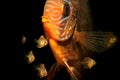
xmin=74 ymin=31 xmax=117 ymax=52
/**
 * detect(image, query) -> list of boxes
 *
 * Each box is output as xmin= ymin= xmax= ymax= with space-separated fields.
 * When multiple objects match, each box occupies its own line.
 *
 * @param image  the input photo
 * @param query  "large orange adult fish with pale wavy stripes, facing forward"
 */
xmin=42 ymin=0 xmax=117 ymax=80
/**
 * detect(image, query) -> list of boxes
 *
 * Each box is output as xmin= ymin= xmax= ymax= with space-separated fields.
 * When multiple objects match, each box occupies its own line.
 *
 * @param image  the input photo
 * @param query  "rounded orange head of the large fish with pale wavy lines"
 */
xmin=42 ymin=0 xmax=78 ymax=41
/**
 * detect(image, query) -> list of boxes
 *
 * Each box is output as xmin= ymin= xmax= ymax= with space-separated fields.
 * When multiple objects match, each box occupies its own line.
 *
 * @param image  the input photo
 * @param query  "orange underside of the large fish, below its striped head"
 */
xmin=47 ymin=39 xmax=92 ymax=80
